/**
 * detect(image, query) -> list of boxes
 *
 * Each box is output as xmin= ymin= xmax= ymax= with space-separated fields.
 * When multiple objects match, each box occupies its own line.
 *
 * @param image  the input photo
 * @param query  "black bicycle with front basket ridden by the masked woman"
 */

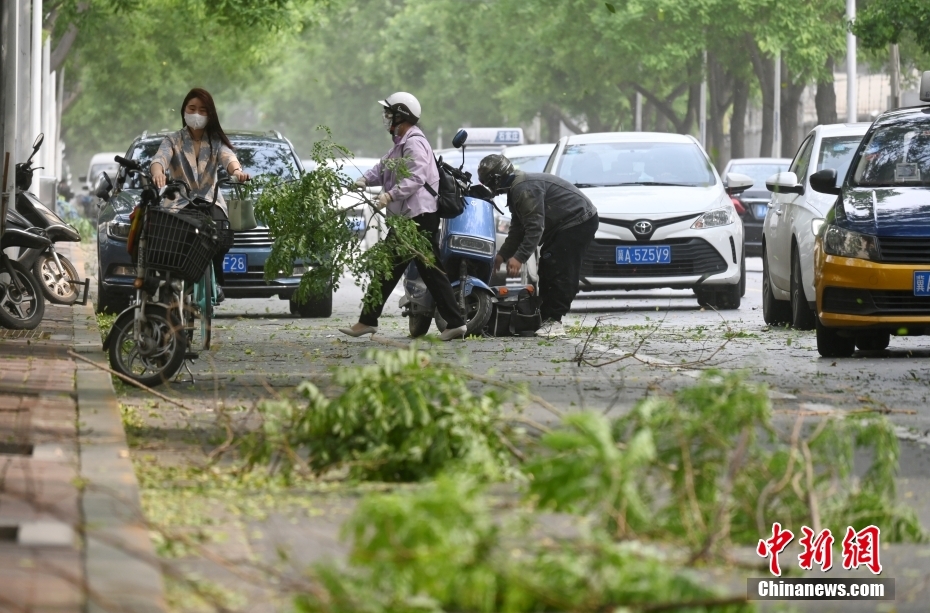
xmin=104 ymin=156 xmax=236 ymax=387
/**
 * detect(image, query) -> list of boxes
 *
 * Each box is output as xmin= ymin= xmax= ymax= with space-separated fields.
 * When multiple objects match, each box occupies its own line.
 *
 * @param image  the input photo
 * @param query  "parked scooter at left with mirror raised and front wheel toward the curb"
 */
xmin=7 ymin=134 xmax=89 ymax=305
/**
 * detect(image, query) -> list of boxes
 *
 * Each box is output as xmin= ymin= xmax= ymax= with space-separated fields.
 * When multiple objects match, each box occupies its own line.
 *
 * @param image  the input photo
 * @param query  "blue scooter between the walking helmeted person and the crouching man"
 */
xmin=400 ymin=130 xmax=500 ymax=338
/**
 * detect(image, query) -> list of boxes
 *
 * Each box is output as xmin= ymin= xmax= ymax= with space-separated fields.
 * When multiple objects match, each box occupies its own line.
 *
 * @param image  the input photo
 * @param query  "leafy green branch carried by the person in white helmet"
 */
xmin=252 ymin=127 xmax=435 ymax=306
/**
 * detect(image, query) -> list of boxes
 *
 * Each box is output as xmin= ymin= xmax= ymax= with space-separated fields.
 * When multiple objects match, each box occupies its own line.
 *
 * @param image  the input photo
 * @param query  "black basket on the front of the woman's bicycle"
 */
xmin=145 ymin=207 xmax=217 ymax=283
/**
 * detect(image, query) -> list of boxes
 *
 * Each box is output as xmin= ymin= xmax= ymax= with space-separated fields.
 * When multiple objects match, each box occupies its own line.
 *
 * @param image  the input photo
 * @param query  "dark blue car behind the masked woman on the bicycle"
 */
xmin=96 ymin=132 xmax=332 ymax=317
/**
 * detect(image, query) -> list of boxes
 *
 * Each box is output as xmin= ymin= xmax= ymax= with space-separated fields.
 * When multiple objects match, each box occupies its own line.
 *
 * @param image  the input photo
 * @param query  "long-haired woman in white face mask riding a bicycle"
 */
xmin=151 ymin=87 xmax=249 ymax=300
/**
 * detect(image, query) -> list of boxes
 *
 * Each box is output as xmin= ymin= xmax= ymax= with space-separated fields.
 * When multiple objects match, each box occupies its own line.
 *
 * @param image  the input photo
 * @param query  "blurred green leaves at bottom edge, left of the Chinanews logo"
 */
xmin=296 ymin=475 xmax=751 ymax=613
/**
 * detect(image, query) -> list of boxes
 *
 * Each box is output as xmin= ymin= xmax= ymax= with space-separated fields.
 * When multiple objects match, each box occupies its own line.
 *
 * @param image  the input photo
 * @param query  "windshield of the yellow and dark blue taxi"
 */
xmin=852 ymin=115 xmax=930 ymax=187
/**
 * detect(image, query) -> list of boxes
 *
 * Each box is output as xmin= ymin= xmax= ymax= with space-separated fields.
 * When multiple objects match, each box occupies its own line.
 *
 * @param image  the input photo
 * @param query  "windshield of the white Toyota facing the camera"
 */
xmin=556 ymin=143 xmax=716 ymax=187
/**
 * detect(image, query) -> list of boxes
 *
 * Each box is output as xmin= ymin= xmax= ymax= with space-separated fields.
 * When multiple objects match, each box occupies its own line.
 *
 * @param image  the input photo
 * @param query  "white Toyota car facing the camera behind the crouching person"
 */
xmin=545 ymin=132 xmax=752 ymax=309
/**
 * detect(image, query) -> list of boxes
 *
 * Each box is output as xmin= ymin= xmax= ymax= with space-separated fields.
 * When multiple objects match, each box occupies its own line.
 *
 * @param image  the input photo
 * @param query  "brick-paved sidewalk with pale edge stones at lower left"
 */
xmin=0 ymin=245 xmax=166 ymax=613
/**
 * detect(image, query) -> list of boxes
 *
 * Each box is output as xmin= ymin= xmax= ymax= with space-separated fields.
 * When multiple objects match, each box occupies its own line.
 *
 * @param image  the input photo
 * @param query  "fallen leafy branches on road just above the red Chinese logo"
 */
xmin=527 ymin=372 xmax=924 ymax=557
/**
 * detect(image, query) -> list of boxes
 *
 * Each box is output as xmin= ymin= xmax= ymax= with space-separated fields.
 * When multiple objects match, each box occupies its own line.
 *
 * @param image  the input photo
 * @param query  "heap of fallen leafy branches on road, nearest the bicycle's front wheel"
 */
xmin=241 ymin=347 xmax=511 ymax=481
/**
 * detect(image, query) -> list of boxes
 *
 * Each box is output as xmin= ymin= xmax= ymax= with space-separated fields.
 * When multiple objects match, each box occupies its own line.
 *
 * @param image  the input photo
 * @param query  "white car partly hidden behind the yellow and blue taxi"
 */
xmin=753 ymin=123 xmax=869 ymax=330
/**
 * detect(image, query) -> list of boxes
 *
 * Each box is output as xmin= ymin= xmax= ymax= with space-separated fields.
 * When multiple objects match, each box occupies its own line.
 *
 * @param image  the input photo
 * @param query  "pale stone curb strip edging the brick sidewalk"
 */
xmin=71 ymin=247 xmax=167 ymax=613
